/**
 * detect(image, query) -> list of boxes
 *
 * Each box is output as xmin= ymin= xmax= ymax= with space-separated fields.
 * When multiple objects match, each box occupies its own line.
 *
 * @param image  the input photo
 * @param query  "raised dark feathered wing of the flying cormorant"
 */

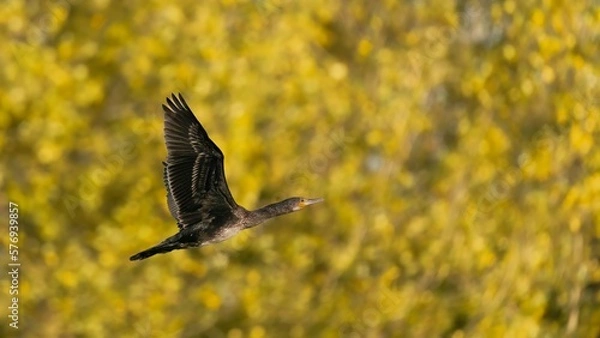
xmin=163 ymin=94 xmax=237 ymax=229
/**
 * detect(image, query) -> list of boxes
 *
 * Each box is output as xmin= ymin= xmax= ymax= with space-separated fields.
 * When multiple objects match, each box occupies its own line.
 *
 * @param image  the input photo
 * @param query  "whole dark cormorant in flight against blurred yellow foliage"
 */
xmin=129 ymin=94 xmax=323 ymax=261
